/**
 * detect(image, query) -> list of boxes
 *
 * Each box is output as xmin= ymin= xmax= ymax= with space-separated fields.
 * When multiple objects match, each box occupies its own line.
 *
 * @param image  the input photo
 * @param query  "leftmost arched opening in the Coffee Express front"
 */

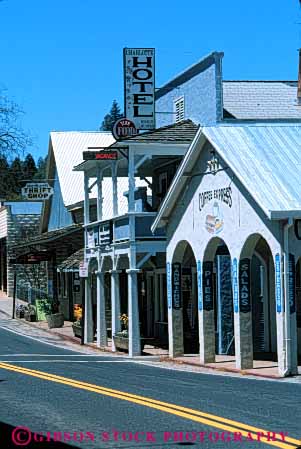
xmin=172 ymin=241 xmax=199 ymax=354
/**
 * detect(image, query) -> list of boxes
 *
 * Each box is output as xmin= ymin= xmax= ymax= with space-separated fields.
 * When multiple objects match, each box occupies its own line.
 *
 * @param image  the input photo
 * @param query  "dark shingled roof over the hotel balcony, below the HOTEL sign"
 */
xmin=113 ymin=120 xmax=198 ymax=147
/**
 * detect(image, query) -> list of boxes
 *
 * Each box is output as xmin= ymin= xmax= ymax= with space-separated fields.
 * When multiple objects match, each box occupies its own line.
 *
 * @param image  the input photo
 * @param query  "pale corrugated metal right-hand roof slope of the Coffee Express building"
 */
xmin=203 ymin=124 xmax=301 ymax=212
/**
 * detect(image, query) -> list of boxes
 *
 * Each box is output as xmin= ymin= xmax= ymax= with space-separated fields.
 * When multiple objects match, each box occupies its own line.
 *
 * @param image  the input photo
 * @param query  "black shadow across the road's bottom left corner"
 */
xmin=0 ymin=422 xmax=85 ymax=449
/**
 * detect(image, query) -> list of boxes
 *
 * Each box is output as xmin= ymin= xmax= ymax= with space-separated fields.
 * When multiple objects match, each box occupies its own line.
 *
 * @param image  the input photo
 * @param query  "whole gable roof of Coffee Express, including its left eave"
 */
xmin=152 ymin=123 xmax=301 ymax=232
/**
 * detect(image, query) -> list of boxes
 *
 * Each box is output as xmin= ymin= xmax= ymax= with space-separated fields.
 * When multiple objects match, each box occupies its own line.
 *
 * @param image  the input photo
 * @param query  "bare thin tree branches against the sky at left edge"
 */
xmin=0 ymin=89 xmax=31 ymax=157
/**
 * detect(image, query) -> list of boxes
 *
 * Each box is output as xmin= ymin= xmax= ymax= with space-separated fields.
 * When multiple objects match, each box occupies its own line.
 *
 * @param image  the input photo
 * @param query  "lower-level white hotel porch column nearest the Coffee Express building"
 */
xmin=126 ymin=269 xmax=141 ymax=357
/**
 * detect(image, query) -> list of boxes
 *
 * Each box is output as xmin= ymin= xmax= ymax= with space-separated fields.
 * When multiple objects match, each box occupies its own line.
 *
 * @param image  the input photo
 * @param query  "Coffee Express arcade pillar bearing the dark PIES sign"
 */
xmin=197 ymin=260 xmax=215 ymax=365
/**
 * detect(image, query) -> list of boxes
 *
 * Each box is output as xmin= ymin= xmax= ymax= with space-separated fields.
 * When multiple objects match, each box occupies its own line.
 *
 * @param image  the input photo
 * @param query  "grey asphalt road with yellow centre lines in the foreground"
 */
xmin=0 ymin=320 xmax=301 ymax=449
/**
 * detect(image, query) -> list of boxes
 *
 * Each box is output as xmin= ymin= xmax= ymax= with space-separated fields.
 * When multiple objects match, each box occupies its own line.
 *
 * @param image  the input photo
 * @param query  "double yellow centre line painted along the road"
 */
xmin=0 ymin=362 xmax=301 ymax=449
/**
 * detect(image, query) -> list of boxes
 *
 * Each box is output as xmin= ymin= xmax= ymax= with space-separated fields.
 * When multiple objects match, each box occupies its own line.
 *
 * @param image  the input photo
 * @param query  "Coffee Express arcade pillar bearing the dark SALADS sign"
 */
xmin=232 ymin=258 xmax=253 ymax=370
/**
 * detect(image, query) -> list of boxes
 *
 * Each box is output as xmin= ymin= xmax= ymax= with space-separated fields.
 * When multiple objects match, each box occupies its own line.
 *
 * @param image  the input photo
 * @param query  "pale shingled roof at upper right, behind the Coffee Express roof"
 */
xmin=223 ymin=81 xmax=301 ymax=120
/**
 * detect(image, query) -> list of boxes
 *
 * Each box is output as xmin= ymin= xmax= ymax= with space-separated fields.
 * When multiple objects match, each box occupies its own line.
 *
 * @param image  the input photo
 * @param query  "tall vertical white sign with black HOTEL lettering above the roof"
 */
xmin=123 ymin=48 xmax=156 ymax=130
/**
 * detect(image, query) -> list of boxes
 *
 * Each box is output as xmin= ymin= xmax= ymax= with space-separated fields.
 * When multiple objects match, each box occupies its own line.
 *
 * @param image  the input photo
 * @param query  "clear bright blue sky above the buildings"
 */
xmin=0 ymin=0 xmax=301 ymax=158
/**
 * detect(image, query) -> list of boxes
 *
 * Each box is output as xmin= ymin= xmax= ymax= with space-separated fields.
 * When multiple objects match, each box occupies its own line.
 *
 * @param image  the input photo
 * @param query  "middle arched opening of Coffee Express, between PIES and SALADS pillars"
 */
xmin=203 ymin=237 xmax=235 ymax=355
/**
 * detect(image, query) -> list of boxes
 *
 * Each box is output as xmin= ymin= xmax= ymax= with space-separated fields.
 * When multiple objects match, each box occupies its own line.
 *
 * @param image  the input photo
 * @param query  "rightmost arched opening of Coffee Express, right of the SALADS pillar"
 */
xmin=240 ymin=234 xmax=277 ymax=361
